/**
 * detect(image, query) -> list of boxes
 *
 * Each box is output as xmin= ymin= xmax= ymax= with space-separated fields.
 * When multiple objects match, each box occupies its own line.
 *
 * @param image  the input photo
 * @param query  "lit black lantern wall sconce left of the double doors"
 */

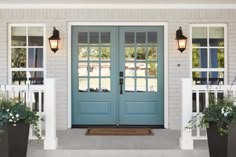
xmin=48 ymin=27 xmax=60 ymax=53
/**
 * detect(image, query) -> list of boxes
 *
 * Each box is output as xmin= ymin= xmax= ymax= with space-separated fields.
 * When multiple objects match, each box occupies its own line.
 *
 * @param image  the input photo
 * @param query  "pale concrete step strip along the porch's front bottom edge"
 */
xmin=27 ymin=149 xmax=209 ymax=157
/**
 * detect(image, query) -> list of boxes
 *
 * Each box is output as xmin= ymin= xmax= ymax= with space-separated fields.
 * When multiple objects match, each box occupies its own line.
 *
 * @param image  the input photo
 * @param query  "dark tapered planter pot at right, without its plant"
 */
xmin=207 ymin=123 xmax=236 ymax=157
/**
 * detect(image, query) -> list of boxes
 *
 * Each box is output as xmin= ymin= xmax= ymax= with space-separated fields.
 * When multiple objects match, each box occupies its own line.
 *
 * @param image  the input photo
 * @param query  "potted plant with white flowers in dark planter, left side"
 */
xmin=0 ymin=96 xmax=41 ymax=157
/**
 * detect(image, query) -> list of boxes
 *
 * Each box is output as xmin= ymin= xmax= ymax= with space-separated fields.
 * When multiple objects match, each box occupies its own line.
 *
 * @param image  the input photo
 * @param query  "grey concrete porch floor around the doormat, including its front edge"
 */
xmin=27 ymin=129 xmax=209 ymax=157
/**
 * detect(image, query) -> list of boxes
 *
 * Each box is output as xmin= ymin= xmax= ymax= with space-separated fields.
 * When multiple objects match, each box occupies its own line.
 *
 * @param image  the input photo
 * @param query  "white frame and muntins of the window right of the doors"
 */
xmin=189 ymin=24 xmax=228 ymax=85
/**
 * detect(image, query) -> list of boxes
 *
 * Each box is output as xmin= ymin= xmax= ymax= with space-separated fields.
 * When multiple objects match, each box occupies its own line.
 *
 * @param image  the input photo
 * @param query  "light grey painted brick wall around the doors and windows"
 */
xmin=0 ymin=9 xmax=236 ymax=129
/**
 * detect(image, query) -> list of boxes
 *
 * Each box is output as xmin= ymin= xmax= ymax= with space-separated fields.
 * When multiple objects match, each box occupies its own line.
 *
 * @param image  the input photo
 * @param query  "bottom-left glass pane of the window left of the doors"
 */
xmin=12 ymin=71 xmax=27 ymax=85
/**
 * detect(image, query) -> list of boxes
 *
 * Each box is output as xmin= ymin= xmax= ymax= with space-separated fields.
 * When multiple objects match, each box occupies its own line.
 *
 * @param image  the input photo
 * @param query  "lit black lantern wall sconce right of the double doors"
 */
xmin=176 ymin=27 xmax=187 ymax=53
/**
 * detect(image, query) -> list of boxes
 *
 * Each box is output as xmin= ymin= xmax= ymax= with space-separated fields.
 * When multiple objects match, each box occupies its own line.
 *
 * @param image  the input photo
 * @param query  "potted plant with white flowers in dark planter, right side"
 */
xmin=188 ymin=93 xmax=236 ymax=157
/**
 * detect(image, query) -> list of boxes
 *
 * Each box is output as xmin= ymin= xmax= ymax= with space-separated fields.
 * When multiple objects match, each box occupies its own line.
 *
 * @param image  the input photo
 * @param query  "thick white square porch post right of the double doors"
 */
xmin=179 ymin=78 xmax=193 ymax=149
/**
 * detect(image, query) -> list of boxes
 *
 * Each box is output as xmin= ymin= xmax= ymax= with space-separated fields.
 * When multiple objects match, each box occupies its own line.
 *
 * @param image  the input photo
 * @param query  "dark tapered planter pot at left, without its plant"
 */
xmin=0 ymin=122 xmax=29 ymax=157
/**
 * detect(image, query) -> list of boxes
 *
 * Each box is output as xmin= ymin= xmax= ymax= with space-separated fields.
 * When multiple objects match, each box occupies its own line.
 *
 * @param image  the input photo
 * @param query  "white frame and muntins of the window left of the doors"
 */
xmin=8 ymin=23 xmax=46 ymax=84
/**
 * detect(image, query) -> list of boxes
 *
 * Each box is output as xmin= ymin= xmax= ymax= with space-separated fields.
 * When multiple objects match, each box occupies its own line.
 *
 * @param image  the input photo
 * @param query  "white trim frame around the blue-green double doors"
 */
xmin=67 ymin=22 xmax=169 ymax=128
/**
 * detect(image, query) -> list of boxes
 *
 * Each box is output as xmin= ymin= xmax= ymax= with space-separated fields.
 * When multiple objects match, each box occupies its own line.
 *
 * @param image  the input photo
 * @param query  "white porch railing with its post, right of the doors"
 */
xmin=180 ymin=78 xmax=236 ymax=149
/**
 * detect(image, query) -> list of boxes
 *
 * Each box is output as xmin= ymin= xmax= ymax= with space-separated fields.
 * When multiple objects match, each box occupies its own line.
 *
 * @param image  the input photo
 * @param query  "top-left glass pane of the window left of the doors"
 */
xmin=11 ymin=27 xmax=26 ymax=46
